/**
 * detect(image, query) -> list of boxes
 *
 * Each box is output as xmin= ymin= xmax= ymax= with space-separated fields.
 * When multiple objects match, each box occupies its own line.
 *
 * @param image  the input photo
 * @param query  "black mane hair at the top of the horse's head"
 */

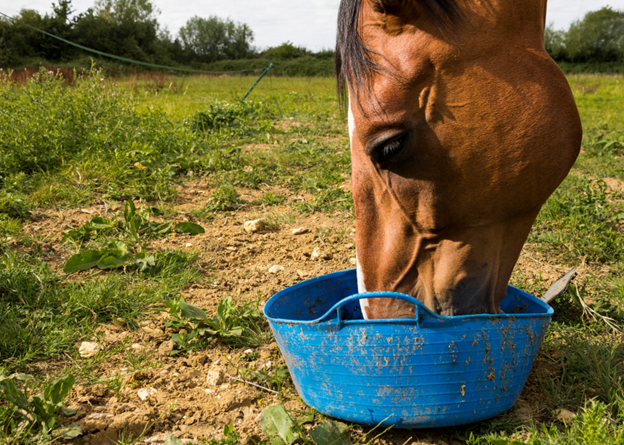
xmin=336 ymin=0 xmax=461 ymax=106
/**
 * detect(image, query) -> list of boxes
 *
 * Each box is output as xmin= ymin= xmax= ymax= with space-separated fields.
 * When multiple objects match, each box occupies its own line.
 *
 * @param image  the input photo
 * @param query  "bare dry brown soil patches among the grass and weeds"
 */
xmin=16 ymin=179 xmax=588 ymax=445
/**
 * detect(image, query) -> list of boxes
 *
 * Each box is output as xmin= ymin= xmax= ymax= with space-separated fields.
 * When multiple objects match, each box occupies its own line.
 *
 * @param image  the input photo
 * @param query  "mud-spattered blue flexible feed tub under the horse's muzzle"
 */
xmin=264 ymin=269 xmax=553 ymax=428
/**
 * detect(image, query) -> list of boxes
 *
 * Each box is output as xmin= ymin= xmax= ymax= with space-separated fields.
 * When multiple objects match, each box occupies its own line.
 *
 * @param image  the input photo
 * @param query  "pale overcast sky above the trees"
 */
xmin=0 ymin=0 xmax=624 ymax=51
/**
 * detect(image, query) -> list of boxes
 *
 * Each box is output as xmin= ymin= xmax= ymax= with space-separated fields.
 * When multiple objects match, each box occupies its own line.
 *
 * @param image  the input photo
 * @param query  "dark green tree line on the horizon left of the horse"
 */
xmin=0 ymin=0 xmax=334 ymax=68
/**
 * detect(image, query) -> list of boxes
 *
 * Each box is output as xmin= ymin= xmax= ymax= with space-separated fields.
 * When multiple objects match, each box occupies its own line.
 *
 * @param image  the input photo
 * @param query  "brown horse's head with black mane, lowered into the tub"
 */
xmin=336 ymin=0 xmax=582 ymax=319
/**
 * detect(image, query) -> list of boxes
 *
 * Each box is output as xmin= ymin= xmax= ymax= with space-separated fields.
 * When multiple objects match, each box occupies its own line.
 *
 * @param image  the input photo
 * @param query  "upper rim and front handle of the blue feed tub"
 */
xmin=263 ymin=268 xmax=555 ymax=325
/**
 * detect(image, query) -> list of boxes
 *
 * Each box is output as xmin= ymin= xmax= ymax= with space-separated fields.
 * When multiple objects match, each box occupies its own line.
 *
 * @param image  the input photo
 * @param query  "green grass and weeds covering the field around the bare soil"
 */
xmin=0 ymin=67 xmax=624 ymax=445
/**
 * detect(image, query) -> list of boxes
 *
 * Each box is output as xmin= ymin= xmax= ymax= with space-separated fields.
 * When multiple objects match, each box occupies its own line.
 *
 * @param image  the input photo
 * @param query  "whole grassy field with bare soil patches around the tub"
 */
xmin=0 ymin=72 xmax=624 ymax=445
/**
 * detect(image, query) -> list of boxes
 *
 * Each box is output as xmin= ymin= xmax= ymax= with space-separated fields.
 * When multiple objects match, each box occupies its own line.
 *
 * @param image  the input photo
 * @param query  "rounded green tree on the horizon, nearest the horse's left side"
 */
xmin=180 ymin=16 xmax=254 ymax=63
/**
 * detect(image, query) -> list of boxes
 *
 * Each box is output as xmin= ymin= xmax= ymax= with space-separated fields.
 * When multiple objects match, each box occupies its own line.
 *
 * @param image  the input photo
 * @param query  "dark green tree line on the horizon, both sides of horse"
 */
xmin=0 ymin=0 xmax=624 ymax=75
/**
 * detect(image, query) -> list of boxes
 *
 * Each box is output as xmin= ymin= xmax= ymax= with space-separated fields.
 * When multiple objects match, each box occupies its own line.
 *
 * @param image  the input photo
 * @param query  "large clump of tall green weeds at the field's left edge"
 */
xmin=0 ymin=69 xmax=198 ymax=200
